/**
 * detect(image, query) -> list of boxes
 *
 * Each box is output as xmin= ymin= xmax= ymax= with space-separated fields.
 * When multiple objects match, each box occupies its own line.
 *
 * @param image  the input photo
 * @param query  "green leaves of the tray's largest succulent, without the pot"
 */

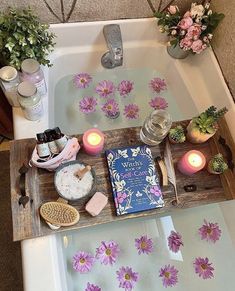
xmin=193 ymin=106 xmax=228 ymax=134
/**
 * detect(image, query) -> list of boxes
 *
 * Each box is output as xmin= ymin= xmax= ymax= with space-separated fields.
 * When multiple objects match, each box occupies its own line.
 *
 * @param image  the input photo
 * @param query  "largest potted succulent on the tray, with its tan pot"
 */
xmin=186 ymin=106 xmax=228 ymax=143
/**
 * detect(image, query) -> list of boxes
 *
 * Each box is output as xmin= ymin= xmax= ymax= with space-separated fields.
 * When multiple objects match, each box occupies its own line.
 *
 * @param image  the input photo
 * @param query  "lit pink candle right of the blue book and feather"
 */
xmin=177 ymin=150 xmax=206 ymax=175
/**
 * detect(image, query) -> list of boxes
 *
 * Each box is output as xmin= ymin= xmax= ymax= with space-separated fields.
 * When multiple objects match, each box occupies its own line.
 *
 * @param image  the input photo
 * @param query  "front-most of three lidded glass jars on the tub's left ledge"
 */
xmin=17 ymin=81 xmax=43 ymax=120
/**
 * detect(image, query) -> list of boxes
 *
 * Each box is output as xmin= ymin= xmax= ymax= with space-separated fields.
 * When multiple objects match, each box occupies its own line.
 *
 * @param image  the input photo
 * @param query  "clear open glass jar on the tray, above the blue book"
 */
xmin=140 ymin=109 xmax=172 ymax=145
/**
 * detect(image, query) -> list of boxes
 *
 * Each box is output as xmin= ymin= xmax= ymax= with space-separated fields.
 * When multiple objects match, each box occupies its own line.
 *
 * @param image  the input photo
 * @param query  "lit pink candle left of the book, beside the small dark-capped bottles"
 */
xmin=82 ymin=128 xmax=104 ymax=155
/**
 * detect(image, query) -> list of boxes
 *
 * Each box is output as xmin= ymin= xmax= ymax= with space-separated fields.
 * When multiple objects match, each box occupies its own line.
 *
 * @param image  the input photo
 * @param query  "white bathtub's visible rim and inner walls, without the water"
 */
xmin=13 ymin=19 xmax=235 ymax=291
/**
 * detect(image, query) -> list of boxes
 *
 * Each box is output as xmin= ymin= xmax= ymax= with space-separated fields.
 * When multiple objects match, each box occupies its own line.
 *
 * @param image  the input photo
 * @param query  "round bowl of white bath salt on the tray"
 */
xmin=54 ymin=160 xmax=96 ymax=202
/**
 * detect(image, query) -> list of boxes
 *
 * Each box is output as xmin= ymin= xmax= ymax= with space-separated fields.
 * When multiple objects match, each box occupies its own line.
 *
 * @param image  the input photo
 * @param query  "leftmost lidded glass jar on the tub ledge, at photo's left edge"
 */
xmin=0 ymin=66 xmax=20 ymax=107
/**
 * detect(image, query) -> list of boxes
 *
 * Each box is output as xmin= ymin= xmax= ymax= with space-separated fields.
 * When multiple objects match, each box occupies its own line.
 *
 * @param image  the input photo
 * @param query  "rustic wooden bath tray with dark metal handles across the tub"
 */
xmin=10 ymin=120 xmax=235 ymax=241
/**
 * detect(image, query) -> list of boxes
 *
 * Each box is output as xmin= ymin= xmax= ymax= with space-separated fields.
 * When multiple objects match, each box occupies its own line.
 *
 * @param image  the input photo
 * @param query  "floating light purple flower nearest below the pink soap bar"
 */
xmin=96 ymin=240 xmax=120 ymax=265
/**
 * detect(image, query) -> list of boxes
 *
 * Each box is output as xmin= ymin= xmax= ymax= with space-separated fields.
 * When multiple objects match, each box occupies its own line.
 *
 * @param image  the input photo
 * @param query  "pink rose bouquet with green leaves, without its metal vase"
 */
xmin=155 ymin=3 xmax=224 ymax=54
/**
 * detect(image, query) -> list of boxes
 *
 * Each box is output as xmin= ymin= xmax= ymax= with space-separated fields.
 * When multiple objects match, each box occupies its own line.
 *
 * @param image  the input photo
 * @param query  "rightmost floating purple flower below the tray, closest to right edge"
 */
xmin=198 ymin=219 xmax=221 ymax=243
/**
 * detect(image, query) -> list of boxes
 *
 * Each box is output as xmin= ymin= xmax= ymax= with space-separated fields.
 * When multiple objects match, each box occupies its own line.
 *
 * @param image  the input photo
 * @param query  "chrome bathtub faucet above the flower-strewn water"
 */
xmin=101 ymin=24 xmax=123 ymax=69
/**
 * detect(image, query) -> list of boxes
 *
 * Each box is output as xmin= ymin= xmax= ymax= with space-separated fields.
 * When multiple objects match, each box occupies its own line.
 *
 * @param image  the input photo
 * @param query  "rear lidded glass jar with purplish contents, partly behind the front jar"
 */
xmin=21 ymin=59 xmax=47 ymax=97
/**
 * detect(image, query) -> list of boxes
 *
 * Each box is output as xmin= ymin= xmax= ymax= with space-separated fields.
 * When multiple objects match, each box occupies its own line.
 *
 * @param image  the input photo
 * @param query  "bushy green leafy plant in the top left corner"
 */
xmin=0 ymin=8 xmax=55 ymax=70
